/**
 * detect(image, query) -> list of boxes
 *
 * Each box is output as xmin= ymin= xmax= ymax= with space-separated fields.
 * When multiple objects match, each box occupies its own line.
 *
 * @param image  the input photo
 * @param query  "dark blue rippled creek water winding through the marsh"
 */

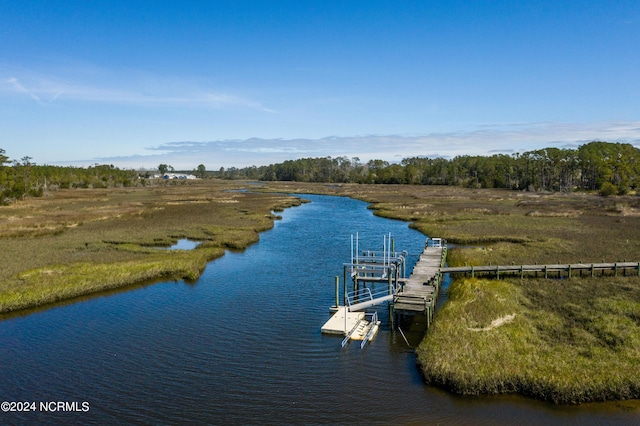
xmin=0 ymin=196 xmax=640 ymax=425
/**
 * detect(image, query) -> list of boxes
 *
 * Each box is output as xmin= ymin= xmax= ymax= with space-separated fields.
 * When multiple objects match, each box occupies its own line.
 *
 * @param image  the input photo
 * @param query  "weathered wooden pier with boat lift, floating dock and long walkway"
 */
xmin=322 ymin=235 xmax=640 ymax=347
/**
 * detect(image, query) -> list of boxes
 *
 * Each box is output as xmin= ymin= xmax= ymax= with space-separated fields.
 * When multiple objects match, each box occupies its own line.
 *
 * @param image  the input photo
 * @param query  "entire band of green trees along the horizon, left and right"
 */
xmin=0 ymin=141 xmax=640 ymax=204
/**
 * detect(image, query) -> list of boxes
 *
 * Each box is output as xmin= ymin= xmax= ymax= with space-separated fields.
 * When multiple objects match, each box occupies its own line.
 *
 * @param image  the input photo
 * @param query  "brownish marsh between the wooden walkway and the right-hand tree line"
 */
xmin=264 ymin=182 xmax=640 ymax=266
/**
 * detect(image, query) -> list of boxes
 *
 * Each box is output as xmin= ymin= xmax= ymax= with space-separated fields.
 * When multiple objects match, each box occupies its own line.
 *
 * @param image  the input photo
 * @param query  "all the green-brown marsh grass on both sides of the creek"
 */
xmin=0 ymin=181 xmax=640 ymax=403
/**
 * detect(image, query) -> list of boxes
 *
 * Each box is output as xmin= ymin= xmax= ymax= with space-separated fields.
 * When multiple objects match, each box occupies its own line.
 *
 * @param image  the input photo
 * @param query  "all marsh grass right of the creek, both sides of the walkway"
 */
xmin=255 ymin=184 xmax=640 ymax=403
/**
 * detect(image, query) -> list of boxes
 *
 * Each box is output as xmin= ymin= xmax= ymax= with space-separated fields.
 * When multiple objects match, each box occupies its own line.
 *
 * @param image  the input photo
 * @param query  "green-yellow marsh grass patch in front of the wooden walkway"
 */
xmin=417 ymin=278 xmax=640 ymax=404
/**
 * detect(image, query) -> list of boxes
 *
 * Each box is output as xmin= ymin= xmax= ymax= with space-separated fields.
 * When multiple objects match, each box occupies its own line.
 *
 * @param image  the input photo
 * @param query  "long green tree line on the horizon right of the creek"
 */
xmin=218 ymin=141 xmax=640 ymax=195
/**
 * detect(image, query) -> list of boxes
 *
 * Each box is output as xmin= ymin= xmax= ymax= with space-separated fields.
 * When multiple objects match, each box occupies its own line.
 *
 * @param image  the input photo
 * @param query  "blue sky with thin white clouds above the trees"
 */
xmin=0 ymin=0 xmax=640 ymax=170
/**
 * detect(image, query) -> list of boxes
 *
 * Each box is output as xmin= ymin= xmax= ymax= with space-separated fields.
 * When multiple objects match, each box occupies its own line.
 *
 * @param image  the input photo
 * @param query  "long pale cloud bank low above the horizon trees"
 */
xmin=75 ymin=121 xmax=640 ymax=169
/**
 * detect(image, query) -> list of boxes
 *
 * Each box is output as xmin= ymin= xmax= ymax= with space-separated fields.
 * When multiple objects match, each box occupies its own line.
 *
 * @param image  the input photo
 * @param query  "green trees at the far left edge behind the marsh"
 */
xmin=0 ymin=148 xmax=138 ymax=205
